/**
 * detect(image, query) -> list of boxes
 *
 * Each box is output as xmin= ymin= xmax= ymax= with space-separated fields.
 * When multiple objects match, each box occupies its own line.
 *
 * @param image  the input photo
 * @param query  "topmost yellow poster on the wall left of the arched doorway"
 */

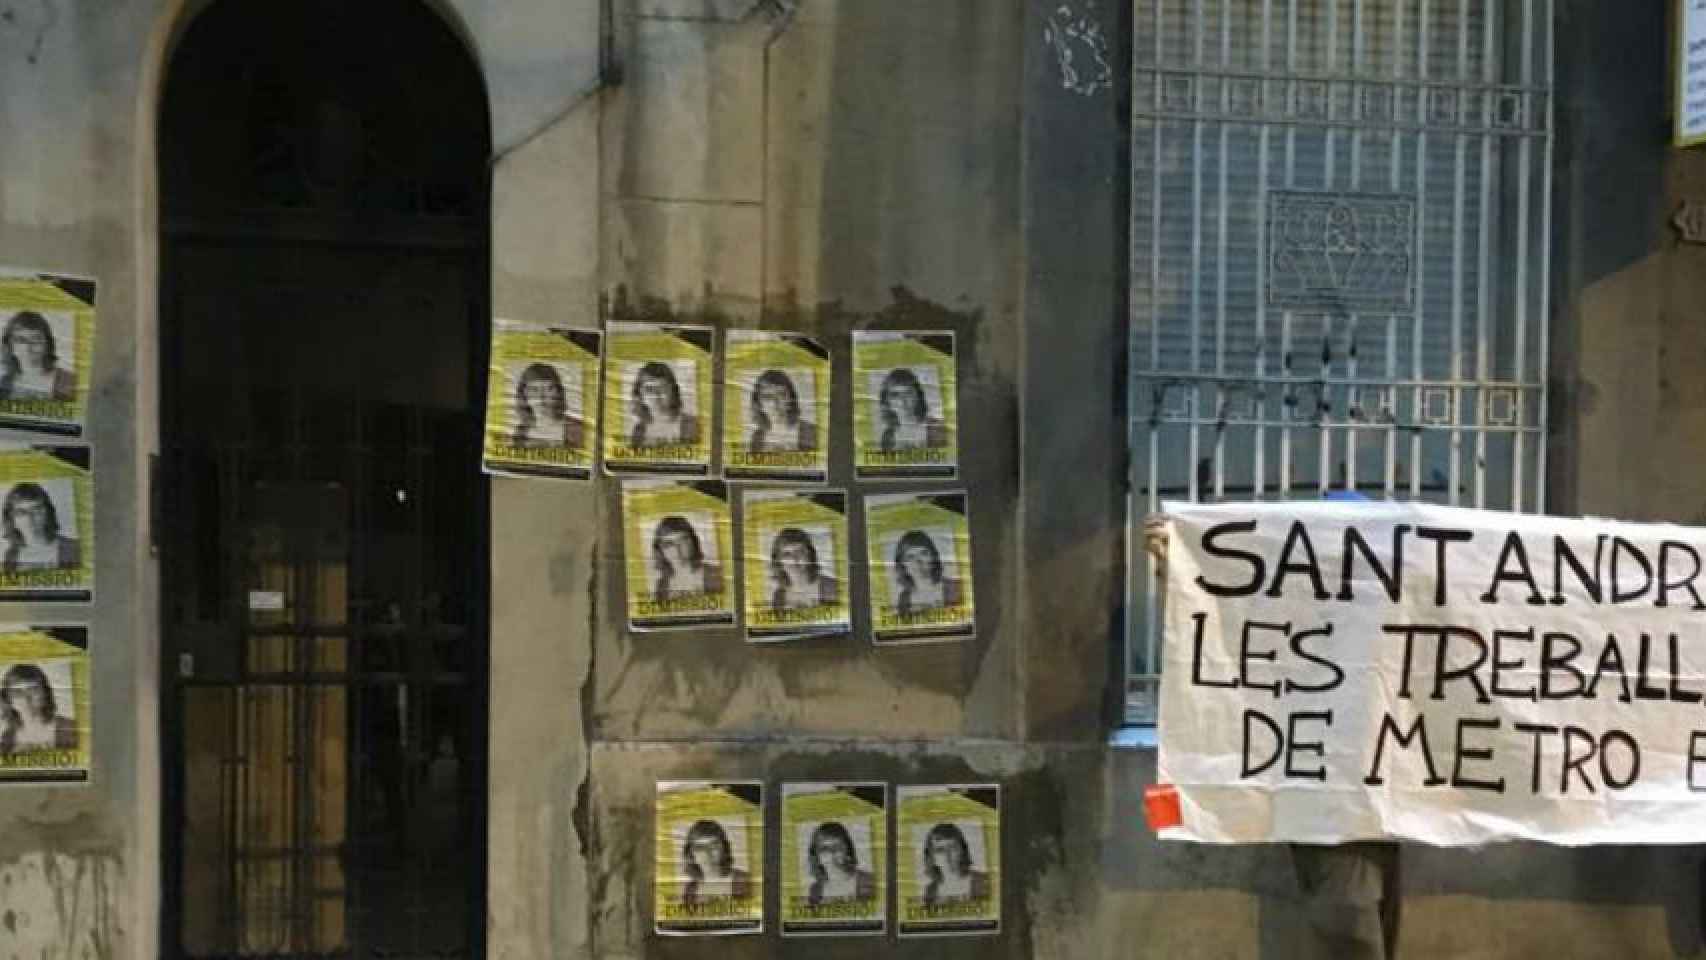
xmin=0 ymin=266 xmax=96 ymax=438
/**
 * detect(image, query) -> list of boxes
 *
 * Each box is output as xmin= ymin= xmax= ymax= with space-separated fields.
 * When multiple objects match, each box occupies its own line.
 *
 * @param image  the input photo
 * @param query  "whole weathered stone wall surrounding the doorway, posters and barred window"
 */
xmin=0 ymin=0 xmax=1706 ymax=960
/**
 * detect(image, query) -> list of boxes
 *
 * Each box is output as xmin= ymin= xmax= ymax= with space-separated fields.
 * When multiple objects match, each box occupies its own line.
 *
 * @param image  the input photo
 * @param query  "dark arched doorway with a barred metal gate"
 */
xmin=155 ymin=0 xmax=490 ymax=958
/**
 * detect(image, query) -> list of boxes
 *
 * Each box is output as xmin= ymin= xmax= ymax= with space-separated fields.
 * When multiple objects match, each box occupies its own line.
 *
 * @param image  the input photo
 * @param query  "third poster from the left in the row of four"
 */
xmin=723 ymin=331 xmax=829 ymax=483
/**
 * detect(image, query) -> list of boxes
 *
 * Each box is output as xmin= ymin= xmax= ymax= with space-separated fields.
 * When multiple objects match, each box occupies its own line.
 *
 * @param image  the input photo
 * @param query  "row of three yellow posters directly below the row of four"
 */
xmin=623 ymin=481 xmax=978 ymax=645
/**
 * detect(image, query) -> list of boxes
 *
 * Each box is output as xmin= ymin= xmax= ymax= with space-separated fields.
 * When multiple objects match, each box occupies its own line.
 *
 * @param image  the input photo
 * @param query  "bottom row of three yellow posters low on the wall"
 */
xmin=653 ymin=781 xmax=1001 ymax=936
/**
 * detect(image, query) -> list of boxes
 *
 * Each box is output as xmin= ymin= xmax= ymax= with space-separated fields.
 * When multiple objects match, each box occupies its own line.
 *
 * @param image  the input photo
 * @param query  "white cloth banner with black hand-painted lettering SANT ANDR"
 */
xmin=1158 ymin=501 xmax=1706 ymax=846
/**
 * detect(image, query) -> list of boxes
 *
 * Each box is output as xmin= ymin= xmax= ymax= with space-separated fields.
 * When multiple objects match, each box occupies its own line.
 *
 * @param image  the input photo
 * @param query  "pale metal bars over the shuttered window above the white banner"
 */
xmin=1126 ymin=0 xmax=1552 ymax=723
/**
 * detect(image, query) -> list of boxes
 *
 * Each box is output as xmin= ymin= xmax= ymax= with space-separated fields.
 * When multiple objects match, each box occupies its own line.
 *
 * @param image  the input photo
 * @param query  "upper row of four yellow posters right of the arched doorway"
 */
xmin=485 ymin=319 xmax=959 ymax=484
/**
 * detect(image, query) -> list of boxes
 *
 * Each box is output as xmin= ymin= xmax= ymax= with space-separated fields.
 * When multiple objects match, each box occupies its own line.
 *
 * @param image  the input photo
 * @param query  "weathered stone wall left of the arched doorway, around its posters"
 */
xmin=0 ymin=0 xmax=159 ymax=960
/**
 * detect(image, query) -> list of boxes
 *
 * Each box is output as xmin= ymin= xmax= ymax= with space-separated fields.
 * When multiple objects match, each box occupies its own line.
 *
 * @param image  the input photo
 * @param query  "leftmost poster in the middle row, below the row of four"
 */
xmin=623 ymin=481 xmax=735 ymax=631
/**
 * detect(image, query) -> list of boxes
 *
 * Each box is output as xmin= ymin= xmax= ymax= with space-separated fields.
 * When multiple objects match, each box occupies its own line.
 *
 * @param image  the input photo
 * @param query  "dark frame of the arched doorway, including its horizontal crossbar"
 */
xmin=154 ymin=0 xmax=493 ymax=957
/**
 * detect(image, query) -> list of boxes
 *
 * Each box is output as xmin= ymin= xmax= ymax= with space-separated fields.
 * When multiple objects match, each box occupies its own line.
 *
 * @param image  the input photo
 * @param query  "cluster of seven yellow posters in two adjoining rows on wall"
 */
xmin=485 ymin=319 xmax=976 ymax=645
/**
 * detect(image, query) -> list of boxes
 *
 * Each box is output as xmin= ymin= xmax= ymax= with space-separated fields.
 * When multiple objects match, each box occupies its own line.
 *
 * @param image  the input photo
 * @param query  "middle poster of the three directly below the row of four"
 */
xmin=740 ymin=489 xmax=853 ymax=643
